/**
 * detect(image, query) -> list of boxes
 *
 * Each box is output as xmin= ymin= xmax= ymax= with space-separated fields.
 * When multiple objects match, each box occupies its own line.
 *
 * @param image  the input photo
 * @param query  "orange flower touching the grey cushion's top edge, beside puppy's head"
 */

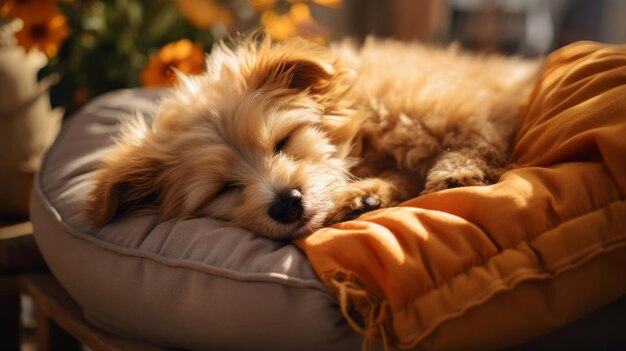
xmin=141 ymin=39 xmax=204 ymax=86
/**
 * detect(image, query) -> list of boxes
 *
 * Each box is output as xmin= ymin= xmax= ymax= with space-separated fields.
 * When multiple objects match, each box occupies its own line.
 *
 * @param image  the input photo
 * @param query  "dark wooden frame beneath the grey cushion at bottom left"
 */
xmin=0 ymin=222 xmax=163 ymax=351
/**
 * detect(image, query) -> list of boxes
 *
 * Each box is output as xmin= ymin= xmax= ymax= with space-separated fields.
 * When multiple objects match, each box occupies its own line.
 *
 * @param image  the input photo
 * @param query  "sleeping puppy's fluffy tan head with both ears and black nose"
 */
xmin=85 ymin=35 xmax=357 ymax=239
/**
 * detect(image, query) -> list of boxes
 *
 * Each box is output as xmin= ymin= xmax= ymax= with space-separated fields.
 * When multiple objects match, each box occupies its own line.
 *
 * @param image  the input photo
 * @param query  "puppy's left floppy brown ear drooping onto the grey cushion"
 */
xmin=83 ymin=150 xmax=161 ymax=225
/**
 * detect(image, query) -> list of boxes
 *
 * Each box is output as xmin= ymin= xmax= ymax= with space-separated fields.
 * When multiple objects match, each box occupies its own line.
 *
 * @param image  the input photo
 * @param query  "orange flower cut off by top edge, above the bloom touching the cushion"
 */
xmin=176 ymin=0 xmax=234 ymax=29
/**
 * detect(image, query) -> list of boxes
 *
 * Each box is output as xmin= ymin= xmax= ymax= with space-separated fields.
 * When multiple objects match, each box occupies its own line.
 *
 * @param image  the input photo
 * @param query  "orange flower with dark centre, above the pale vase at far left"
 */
xmin=11 ymin=7 xmax=70 ymax=57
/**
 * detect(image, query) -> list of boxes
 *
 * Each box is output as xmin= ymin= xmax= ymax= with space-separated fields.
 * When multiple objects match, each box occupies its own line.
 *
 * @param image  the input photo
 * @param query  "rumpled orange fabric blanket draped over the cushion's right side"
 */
xmin=297 ymin=42 xmax=626 ymax=349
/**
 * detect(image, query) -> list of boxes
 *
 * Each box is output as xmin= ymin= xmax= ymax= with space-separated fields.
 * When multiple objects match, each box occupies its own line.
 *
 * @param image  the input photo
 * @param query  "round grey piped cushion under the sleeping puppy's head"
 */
xmin=31 ymin=89 xmax=362 ymax=350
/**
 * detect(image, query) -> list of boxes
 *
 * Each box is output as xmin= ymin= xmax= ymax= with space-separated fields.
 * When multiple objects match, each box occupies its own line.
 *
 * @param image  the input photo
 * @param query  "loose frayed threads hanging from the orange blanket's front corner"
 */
xmin=330 ymin=277 xmax=389 ymax=351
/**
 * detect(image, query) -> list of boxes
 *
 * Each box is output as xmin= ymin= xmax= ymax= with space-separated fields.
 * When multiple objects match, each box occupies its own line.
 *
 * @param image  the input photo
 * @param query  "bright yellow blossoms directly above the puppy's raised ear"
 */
xmin=261 ymin=3 xmax=328 ymax=42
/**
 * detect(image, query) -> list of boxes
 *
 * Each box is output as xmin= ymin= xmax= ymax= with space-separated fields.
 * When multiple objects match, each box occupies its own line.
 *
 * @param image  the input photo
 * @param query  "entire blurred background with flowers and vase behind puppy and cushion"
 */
xmin=0 ymin=0 xmax=626 ymax=220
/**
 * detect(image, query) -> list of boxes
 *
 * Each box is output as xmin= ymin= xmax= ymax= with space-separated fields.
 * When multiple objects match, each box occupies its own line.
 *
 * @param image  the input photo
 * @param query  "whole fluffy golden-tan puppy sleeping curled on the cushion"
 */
xmin=84 ymin=34 xmax=540 ymax=240
